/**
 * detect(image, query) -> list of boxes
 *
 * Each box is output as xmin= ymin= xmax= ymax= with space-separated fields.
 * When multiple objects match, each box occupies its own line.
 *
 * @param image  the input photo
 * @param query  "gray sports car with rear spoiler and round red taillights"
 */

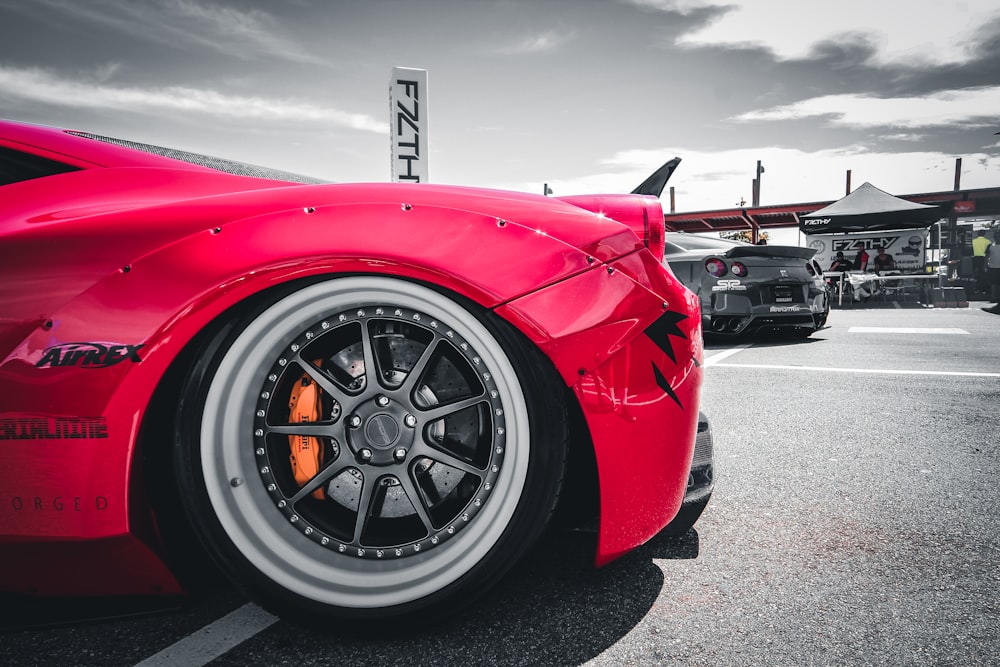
xmin=664 ymin=232 xmax=830 ymax=338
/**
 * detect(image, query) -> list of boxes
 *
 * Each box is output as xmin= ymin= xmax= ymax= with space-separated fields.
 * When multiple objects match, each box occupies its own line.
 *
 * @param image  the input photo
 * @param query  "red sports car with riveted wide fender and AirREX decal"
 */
xmin=0 ymin=122 xmax=710 ymax=621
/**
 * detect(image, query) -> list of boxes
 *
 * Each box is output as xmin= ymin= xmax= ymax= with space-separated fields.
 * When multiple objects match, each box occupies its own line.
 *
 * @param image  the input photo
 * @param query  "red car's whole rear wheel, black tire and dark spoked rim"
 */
xmin=174 ymin=276 xmax=567 ymax=628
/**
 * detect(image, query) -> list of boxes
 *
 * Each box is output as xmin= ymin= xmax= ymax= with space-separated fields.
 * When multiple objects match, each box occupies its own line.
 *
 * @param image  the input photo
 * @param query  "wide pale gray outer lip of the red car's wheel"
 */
xmin=200 ymin=277 xmax=530 ymax=608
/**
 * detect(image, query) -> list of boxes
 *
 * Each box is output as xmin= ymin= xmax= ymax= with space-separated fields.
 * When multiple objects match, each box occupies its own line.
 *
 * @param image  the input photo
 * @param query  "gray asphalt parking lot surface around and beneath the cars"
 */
xmin=0 ymin=303 xmax=1000 ymax=666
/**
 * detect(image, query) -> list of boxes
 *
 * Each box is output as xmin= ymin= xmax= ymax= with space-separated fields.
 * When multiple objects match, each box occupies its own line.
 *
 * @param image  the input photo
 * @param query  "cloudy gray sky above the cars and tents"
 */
xmin=0 ymin=0 xmax=1000 ymax=217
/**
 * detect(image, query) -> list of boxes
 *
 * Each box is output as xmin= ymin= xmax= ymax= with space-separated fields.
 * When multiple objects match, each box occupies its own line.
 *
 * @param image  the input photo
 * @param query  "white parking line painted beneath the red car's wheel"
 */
xmin=136 ymin=603 xmax=278 ymax=667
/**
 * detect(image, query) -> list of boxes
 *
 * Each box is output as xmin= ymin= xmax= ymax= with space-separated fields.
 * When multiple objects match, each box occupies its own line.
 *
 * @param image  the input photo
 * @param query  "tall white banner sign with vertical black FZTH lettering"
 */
xmin=389 ymin=67 xmax=428 ymax=183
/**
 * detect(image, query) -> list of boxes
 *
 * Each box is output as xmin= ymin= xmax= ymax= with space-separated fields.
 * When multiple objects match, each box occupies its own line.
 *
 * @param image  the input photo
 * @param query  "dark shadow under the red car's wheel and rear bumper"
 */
xmin=236 ymin=530 xmax=699 ymax=665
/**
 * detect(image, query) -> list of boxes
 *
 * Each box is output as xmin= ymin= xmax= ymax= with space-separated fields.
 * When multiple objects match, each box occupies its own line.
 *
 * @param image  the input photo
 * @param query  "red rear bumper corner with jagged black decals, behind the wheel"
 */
xmin=497 ymin=252 xmax=702 ymax=565
